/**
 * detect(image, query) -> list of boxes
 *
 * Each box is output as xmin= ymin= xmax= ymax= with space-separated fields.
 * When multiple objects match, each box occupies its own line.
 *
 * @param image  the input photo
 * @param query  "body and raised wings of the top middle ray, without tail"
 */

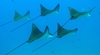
xmin=40 ymin=4 xmax=60 ymax=16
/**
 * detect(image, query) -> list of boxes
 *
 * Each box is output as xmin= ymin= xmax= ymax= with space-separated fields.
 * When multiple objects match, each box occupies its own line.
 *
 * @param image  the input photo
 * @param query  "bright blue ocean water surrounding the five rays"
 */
xmin=0 ymin=0 xmax=100 ymax=55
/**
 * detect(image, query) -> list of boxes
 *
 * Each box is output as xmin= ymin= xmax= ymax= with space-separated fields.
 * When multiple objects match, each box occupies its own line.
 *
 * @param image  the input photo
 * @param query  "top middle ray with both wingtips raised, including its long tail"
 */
xmin=11 ymin=4 xmax=60 ymax=32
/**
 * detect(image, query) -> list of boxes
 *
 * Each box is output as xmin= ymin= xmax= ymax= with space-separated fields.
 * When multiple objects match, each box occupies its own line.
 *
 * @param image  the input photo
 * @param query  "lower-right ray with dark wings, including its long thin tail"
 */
xmin=32 ymin=23 xmax=78 ymax=52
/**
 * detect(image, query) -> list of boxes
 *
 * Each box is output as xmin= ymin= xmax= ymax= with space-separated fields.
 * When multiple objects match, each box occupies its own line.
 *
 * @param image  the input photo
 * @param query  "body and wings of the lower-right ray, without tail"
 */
xmin=57 ymin=23 xmax=78 ymax=38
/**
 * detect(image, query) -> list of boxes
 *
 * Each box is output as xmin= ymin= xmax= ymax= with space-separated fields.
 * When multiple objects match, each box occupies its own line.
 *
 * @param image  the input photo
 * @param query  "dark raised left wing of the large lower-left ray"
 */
xmin=27 ymin=24 xmax=43 ymax=43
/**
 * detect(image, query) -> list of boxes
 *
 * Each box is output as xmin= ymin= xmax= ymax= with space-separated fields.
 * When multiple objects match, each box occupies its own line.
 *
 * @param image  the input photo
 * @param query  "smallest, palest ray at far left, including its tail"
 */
xmin=0 ymin=11 xmax=30 ymax=27
